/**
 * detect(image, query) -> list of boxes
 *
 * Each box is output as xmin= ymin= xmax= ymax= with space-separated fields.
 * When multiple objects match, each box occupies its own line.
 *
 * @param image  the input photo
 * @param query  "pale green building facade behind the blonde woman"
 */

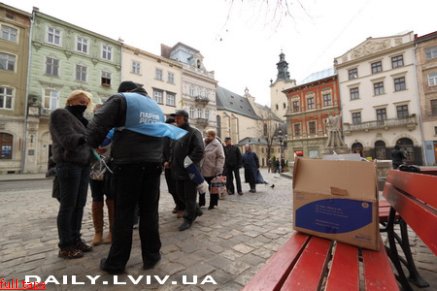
xmin=24 ymin=8 xmax=121 ymax=172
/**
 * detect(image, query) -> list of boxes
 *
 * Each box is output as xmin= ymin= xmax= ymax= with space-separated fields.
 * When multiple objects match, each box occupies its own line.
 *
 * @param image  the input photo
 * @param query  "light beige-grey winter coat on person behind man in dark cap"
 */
xmin=200 ymin=138 xmax=225 ymax=177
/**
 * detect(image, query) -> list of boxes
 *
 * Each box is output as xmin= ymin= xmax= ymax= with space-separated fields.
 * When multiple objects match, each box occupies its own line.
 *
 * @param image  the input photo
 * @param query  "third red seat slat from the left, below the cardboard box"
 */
xmin=325 ymin=242 xmax=360 ymax=291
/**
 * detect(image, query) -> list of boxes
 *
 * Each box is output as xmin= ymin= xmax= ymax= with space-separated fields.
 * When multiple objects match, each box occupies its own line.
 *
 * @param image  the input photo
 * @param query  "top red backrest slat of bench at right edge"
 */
xmin=387 ymin=170 xmax=437 ymax=209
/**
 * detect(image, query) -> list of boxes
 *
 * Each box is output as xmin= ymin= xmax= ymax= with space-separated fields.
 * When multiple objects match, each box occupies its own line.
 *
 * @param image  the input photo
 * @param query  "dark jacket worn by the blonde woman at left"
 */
xmin=50 ymin=108 xmax=91 ymax=165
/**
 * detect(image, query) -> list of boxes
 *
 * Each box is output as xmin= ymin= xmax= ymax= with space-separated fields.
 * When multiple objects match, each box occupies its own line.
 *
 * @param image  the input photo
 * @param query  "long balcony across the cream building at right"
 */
xmin=343 ymin=114 xmax=417 ymax=135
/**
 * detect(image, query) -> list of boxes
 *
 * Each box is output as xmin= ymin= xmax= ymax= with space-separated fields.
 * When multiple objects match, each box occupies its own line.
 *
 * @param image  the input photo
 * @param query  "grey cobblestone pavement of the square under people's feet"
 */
xmin=0 ymin=170 xmax=437 ymax=290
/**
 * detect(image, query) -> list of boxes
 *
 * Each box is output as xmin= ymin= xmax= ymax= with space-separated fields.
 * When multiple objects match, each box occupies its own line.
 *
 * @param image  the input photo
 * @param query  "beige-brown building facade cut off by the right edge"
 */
xmin=416 ymin=31 xmax=437 ymax=165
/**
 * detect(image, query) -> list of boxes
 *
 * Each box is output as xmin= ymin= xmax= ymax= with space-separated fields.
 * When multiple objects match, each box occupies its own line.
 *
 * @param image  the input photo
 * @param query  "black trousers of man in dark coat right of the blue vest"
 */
xmin=176 ymin=179 xmax=200 ymax=223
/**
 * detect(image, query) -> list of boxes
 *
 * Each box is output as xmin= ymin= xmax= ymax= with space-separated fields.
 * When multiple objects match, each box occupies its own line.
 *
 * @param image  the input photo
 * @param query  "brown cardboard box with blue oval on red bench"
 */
xmin=293 ymin=158 xmax=380 ymax=250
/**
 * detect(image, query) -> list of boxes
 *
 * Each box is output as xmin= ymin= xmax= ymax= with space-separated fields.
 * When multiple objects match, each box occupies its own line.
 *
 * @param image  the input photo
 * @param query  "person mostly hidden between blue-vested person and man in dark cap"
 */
xmin=163 ymin=114 xmax=185 ymax=218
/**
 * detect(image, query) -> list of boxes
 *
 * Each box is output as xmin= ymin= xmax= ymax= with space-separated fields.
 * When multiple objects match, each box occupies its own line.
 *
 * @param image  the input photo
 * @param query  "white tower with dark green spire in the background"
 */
xmin=270 ymin=52 xmax=296 ymax=122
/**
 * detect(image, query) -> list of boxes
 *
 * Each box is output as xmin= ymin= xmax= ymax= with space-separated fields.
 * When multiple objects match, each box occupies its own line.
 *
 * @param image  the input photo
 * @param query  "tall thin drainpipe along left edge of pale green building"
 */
xmin=20 ymin=10 xmax=35 ymax=174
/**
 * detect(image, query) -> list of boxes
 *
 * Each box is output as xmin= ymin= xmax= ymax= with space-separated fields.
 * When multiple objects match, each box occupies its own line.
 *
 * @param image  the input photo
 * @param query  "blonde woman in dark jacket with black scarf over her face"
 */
xmin=50 ymin=90 xmax=91 ymax=259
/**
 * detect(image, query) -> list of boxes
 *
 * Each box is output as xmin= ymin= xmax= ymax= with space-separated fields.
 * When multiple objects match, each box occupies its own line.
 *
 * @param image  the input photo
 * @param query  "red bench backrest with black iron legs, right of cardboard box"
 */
xmin=384 ymin=168 xmax=437 ymax=290
